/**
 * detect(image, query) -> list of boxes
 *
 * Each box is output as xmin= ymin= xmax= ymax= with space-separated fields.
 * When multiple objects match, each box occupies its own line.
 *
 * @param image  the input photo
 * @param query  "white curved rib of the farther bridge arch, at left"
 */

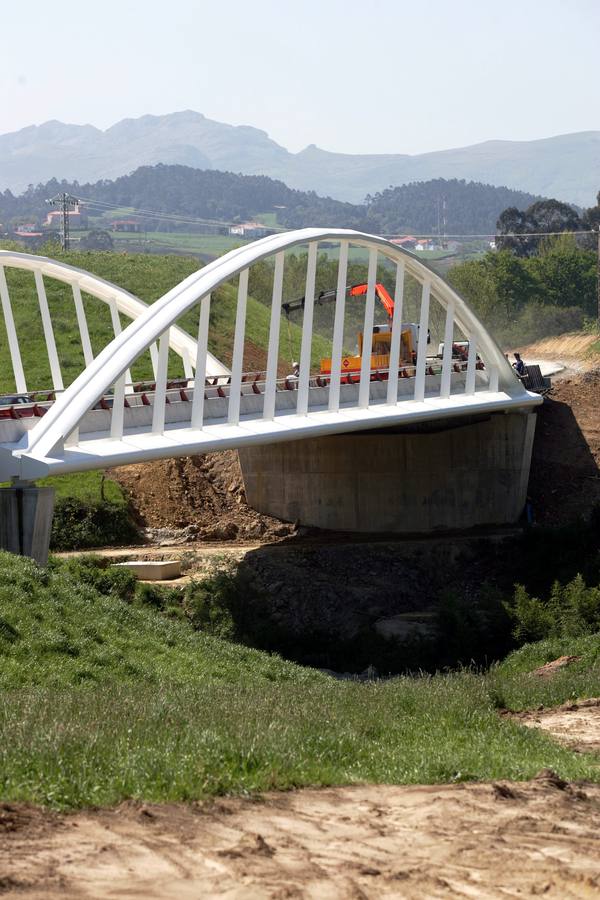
xmin=0 ymin=250 xmax=229 ymax=384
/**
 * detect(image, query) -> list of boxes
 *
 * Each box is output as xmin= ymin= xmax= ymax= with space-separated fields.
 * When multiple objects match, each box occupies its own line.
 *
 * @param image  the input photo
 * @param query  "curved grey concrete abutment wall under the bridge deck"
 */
xmin=239 ymin=413 xmax=535 ymax=533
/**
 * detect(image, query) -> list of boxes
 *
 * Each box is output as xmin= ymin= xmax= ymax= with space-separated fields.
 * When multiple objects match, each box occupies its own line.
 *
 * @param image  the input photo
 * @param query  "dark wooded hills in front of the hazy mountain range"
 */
xmin=0 ymin=165 xmax=537 ymax=235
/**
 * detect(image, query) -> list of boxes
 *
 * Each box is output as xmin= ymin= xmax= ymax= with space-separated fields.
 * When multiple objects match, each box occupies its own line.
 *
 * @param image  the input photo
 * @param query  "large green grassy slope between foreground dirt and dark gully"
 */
xmin=0 ymin=554 xmax=598 ymax=807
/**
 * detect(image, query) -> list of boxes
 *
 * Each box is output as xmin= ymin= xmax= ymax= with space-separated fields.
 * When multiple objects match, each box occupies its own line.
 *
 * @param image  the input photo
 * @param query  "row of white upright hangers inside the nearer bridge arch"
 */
xmin=88 ymin=239 xmax=502 ymax=439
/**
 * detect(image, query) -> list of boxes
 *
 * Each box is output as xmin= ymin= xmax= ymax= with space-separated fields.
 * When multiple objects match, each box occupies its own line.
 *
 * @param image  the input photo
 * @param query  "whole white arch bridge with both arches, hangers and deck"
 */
xmin=0 ymin=228 xmax=541 ymax=482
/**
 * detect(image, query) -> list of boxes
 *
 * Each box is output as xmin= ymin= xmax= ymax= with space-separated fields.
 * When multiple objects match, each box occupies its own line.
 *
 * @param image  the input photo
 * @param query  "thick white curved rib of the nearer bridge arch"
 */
xmin=19 ymin=228 xmax=531 ymax=459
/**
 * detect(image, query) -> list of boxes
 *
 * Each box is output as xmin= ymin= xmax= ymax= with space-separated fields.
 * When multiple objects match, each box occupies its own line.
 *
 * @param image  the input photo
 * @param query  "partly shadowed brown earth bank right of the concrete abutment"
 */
xmin=529 ymin=368 xmax=600 ymax=525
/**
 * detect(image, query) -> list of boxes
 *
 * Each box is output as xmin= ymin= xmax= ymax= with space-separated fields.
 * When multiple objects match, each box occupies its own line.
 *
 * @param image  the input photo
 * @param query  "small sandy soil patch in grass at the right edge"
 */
xmin=514 ymin=699 xmax=600 ymax=753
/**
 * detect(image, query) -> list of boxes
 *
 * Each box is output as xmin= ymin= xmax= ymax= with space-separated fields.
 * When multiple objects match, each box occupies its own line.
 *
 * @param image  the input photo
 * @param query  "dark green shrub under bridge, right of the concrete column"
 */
xmin=50 ymin=497 xmax=139 ymax=550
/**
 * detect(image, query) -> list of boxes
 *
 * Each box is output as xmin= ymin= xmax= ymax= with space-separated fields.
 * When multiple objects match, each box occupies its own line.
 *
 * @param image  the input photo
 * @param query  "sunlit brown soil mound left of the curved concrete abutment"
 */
xmin=110 ymin=450 xmax=294 ymax=541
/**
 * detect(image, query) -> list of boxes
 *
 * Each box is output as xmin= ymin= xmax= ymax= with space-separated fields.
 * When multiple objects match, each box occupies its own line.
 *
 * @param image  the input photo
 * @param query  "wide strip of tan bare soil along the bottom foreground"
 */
xmin=0 ymin=772 xmax=600 ymax=900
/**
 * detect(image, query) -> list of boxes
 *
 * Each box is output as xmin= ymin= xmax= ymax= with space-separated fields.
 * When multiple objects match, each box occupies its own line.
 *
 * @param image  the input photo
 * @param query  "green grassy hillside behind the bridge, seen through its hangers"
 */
xmin=0 ymin=252 xmax=329 ymax=392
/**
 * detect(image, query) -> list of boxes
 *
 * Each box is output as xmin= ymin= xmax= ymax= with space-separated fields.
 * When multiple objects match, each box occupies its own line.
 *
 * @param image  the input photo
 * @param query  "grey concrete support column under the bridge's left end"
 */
xmin=0 ymin=483 xmax=54 ymax=566
